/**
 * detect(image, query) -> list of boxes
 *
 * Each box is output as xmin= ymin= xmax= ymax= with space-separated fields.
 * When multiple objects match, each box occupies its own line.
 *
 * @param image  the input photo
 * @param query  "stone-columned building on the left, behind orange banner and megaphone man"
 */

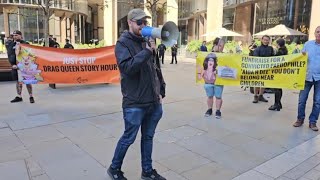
xmin=0 ymin=0 xmax=178 ymax=45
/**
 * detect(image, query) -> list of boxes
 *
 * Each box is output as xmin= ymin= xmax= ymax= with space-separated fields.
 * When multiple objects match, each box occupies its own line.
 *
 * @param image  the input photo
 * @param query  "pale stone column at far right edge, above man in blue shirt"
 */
xmin=309 ymin=0 xmax=320 ymax=40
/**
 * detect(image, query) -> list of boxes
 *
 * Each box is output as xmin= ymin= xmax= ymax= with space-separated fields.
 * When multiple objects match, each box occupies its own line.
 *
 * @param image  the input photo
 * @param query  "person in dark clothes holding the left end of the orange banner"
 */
xmin=8 ymin=30 xmax=34 ymax=103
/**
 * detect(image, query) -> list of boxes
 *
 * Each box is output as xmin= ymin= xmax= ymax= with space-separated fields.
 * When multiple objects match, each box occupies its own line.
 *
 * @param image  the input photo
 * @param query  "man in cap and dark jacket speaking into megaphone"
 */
xmin=107 ymin=9 xmax=166 ymax=180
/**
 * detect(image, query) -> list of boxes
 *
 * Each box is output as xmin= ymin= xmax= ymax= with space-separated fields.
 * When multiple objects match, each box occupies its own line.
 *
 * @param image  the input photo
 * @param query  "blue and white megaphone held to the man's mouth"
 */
xmin=141 ymin=21 xmax=179 ymax=46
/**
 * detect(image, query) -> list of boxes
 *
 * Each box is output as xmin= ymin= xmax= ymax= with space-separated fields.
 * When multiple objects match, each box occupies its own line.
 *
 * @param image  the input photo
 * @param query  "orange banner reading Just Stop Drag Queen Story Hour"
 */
xmin=17 ymin=44 xmax=120 ymax=84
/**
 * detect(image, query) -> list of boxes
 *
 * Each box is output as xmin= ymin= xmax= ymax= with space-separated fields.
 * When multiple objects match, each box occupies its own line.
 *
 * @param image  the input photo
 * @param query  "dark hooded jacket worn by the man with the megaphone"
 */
xmin=115 ymin=31 xmax=165 ymax=108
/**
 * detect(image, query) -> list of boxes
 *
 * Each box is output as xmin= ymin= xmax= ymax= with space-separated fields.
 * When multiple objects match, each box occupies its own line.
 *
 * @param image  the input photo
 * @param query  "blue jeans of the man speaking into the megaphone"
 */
xmin=111 ymin=104 xmax=162 ymax=172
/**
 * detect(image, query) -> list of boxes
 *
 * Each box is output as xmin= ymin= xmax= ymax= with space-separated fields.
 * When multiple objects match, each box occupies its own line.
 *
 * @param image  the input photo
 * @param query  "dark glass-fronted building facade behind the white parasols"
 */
xmin=223 ymin=0 xmax=317 ymax=41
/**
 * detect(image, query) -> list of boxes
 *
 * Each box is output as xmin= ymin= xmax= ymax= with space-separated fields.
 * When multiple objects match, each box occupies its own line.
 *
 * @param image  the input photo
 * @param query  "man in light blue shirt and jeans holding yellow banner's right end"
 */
xmin=293 ymin=26 xmax=320 ymax=131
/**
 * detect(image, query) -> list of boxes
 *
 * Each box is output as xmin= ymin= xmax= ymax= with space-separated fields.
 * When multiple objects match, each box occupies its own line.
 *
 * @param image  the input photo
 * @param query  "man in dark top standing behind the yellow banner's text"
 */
xmin=252 ymin=35 xmax=274 ymax=103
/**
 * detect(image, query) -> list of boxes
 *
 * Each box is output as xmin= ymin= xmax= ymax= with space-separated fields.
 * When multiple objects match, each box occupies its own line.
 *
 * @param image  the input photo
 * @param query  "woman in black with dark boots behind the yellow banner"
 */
xmin=269 ymin=39 xmax=288 ymax=111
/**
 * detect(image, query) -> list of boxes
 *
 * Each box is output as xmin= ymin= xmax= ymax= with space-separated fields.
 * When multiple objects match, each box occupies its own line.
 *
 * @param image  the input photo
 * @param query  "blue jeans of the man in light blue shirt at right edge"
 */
xmin=298 ymin=81 xmax=320 ymax=123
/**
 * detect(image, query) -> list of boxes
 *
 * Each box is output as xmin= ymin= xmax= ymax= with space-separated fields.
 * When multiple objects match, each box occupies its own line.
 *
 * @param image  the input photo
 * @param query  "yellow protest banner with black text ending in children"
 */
xmin=196 ymin=52 xmax=308 ymax=90
